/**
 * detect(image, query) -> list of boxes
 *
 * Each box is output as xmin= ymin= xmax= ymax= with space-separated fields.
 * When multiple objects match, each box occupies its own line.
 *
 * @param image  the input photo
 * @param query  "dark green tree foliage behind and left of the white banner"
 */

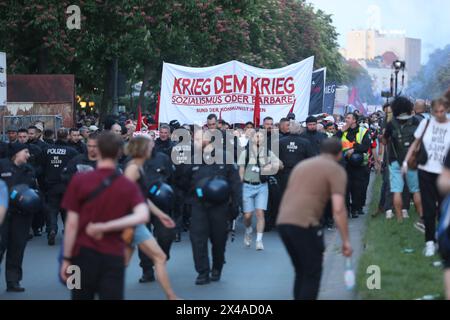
xmin=0 ymin=0 xmax=344 ymax=116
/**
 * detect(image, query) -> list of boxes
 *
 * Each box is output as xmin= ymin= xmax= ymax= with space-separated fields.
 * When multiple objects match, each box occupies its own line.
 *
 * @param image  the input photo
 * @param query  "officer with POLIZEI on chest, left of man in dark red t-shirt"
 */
xmin=42 ymin=128 xmax=78 ymax=246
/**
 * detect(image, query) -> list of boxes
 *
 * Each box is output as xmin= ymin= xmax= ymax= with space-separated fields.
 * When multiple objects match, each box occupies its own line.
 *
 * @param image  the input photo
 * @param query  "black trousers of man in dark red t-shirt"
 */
xmin=72 ymin=248 xmax=125 ymax=300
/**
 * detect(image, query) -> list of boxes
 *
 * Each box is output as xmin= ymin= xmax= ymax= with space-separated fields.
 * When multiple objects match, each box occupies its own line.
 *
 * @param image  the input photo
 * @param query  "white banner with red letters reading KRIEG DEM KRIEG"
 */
xmin=159 ymin=57 xmax=314 ymax=125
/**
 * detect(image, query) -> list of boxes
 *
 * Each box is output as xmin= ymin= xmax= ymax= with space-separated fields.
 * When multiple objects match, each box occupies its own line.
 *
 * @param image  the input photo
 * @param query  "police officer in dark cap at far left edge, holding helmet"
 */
xmin=0 ymin=143 xmax=36 ymax=292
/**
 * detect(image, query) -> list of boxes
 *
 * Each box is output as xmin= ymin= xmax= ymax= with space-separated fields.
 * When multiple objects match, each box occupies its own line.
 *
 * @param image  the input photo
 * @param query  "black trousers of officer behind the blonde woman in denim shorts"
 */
xmin=138 ymin=216 xmax=176 ymax=274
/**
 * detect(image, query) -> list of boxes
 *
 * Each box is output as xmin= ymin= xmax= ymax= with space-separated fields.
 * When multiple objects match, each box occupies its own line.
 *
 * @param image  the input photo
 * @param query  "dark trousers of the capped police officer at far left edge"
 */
xmin=0 ymin=210 xmax=33 ymax=283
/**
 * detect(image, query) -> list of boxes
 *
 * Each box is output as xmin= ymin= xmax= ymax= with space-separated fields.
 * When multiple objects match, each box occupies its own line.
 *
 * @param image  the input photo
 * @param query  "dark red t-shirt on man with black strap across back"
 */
xmin=61 ymin=169 xmax=145 ymax=256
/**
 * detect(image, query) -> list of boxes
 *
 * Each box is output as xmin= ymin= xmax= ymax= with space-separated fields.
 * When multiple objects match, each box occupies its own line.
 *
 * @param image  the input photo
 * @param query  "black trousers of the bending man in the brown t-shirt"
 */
xmin=278 ymin=225 xmax=325 ymax=300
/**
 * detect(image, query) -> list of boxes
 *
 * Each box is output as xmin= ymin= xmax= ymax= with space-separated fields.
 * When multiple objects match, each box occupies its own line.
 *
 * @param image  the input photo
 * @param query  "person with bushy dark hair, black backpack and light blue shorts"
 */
xmin=383 ymin=97 xmax=422 ymax=222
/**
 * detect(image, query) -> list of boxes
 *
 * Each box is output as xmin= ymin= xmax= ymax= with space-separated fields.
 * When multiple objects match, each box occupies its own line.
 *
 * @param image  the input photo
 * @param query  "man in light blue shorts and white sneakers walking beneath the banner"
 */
xmin=238 ymin=131 xmax=283 ymax=251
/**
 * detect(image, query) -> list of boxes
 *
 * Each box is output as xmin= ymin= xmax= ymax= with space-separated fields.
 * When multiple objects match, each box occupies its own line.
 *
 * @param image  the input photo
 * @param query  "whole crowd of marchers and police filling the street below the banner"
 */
xmin=0 ymin=87 xmax=450 ymax=299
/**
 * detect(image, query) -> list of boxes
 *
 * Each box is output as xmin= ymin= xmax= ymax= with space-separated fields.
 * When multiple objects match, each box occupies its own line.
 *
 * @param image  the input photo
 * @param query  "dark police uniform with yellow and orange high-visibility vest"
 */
xmin=338 ymin=126 xmax=370 ymax=218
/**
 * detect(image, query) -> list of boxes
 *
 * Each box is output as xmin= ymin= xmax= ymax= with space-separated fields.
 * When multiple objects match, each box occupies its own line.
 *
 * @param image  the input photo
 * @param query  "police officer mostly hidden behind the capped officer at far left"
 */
xmin=17 ymin=128 xmax=45 ymax=237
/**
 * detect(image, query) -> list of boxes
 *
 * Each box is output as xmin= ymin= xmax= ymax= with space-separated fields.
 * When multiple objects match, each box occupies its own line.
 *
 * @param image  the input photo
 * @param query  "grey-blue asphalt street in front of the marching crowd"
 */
xmin=0 ymin=210 xmax=363 ymax=300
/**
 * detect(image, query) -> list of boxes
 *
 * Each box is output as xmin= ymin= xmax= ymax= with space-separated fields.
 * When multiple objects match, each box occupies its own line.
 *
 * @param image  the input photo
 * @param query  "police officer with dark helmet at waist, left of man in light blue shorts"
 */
xmin=180 ymin=130 xmax=242 ymax=285
